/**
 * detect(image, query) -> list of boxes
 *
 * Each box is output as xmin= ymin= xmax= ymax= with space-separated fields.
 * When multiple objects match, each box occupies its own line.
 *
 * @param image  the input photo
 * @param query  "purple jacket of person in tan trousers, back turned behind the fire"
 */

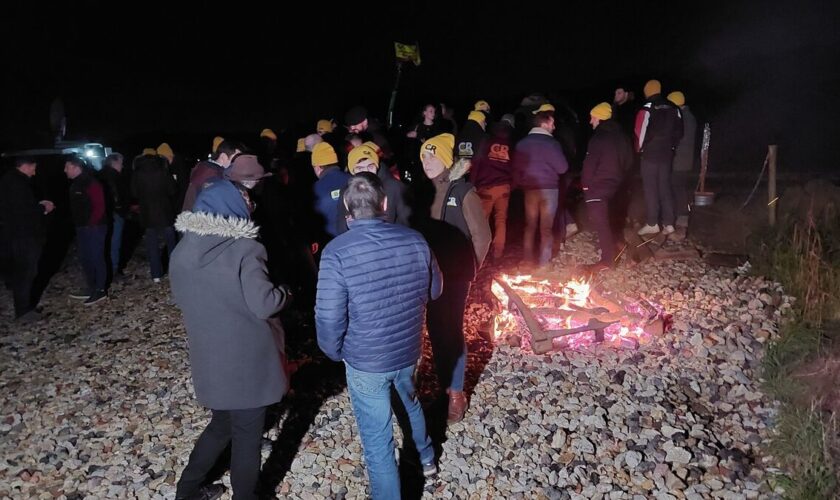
xmin=513 ymin=128 xmax=569 ymax=189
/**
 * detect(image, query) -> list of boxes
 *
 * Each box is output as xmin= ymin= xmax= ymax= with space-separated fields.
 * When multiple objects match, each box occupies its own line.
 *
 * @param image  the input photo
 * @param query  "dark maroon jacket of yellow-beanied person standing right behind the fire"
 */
xmin=581 ymin=120 xmax=633 ymax=200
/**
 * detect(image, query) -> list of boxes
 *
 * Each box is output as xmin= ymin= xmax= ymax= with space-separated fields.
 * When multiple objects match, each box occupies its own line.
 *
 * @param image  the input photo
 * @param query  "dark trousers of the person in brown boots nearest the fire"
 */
xmin=427 ymin=277 xmax=470 ymax=391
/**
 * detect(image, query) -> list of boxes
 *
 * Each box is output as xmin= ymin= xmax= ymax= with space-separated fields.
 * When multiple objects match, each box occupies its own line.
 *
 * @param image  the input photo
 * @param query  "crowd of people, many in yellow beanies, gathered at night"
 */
xmin=0 ymin=80 xmax=696 ymax=498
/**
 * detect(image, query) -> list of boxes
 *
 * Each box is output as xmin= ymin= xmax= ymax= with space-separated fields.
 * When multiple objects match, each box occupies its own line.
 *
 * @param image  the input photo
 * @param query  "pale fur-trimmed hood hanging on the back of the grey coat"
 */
xmin=175 ymin=212 xmax=259 ymax=269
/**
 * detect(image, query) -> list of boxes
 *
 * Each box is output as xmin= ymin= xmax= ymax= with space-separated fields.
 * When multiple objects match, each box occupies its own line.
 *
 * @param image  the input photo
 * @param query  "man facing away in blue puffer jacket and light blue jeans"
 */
xmin=315 ymin=172 xmax=442 ymax=499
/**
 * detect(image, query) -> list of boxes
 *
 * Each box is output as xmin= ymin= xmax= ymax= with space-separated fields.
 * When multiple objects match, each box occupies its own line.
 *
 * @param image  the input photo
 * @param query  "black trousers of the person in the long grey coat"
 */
xmin=175 ymin=406 xmax=265 ymax=500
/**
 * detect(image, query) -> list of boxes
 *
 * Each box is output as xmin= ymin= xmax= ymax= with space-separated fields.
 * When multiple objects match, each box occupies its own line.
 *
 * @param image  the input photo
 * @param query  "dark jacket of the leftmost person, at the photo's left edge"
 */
xmin=0 ymin=168 xmax=45 ymax=243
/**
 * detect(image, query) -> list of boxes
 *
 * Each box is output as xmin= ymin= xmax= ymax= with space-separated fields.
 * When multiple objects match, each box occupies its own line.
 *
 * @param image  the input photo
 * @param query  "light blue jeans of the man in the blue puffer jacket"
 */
xmin=344 ymin=363 xmax=435 ymax=500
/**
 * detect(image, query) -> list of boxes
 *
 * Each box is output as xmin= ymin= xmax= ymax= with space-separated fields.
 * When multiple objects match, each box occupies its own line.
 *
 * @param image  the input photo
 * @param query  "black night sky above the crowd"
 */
xmin=0 ymin=1 xmax=840 ymax=170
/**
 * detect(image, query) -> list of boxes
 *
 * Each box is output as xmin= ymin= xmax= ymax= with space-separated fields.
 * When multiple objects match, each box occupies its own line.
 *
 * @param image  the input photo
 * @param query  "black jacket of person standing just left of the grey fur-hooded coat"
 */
xmin=131 ymin=155 xmax=176 ymax=227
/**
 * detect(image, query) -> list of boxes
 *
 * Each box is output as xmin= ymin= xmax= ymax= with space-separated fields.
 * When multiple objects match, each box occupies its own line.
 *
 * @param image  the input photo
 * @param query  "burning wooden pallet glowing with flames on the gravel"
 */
xmin=492 ymin=275 xmax=664 ymax=354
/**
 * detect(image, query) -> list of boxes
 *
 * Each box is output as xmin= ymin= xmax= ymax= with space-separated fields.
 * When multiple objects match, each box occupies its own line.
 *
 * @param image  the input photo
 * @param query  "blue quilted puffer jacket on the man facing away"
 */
xmin=315 ymin=219 xmax=443 ymax=373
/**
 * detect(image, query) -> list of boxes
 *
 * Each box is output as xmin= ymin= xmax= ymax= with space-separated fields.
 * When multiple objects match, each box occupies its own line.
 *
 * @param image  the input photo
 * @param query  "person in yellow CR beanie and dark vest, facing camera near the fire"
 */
xmin=420 ymin=130 xmax=491 ymax=422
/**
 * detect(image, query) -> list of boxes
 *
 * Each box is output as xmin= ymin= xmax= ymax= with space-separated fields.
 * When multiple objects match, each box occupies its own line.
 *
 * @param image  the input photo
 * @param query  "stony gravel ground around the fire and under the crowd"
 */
xmin=0 ymin=234 xmax=790 ymax=499
